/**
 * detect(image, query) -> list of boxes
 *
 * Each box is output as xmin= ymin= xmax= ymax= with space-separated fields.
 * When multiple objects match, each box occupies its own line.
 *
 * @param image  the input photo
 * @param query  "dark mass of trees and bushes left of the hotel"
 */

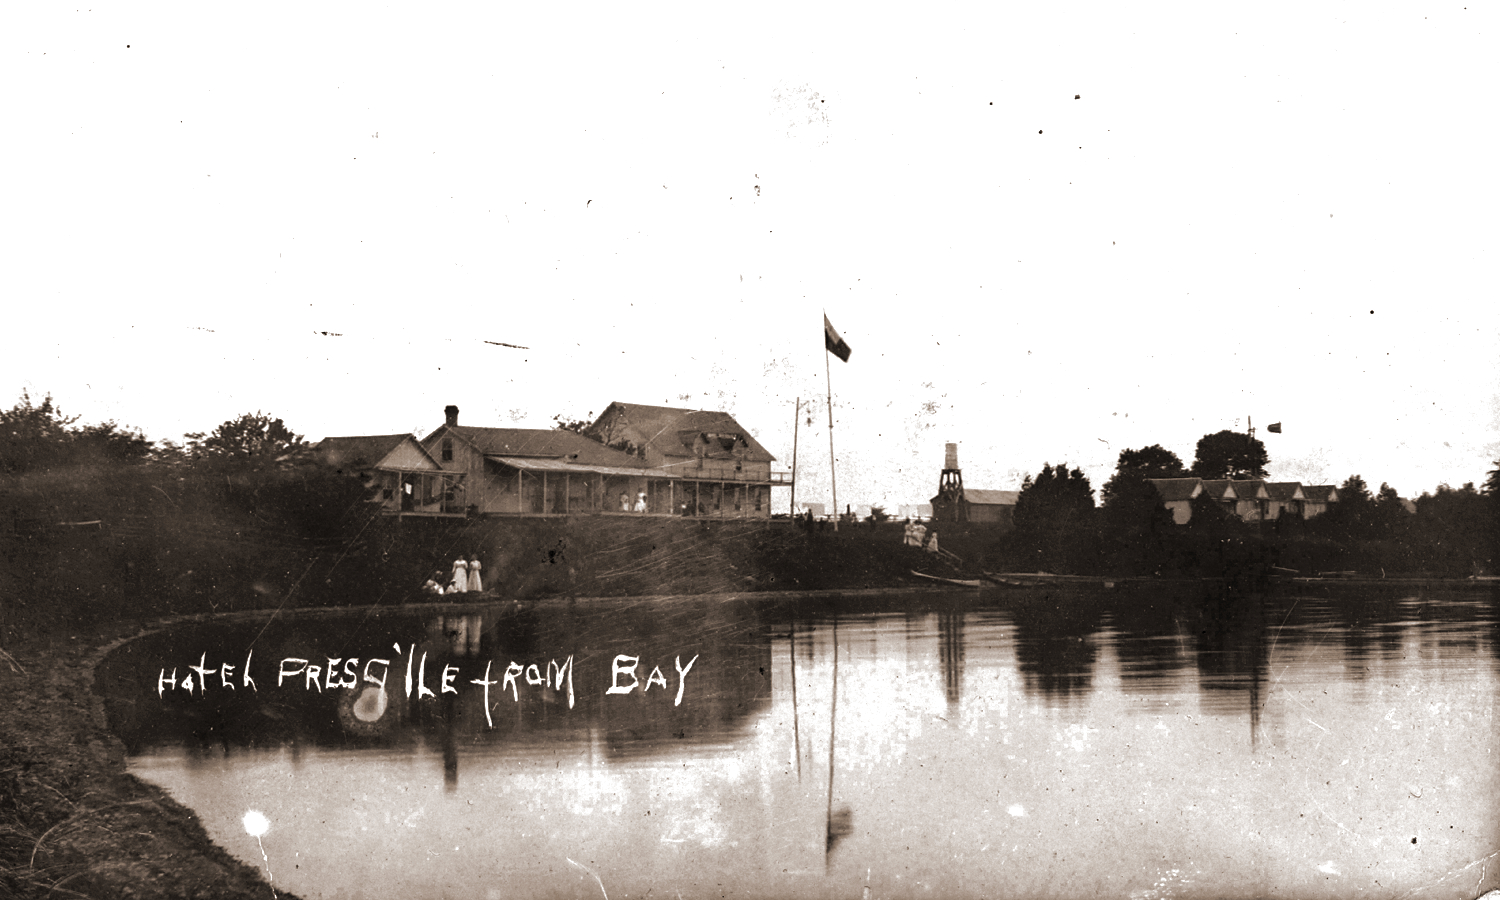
xmin=0 ymin=392 xmax=381 ymax=644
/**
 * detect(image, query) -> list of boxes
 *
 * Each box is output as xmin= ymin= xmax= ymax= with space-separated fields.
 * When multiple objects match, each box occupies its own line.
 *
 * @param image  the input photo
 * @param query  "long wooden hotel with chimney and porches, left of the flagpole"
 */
xmin=315 ymin=402 xmax=792 ymax=518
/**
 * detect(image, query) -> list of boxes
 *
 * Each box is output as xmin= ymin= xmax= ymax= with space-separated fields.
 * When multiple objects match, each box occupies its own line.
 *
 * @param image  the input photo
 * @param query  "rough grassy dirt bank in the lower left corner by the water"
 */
xmin=0 ymin=626 xmax=301 ymax=900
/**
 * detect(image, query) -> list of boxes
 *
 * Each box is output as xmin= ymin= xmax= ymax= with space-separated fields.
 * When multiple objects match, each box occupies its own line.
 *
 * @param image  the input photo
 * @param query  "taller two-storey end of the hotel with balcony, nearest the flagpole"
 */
xmin=587 ymin=401 xmax=792 ymax=518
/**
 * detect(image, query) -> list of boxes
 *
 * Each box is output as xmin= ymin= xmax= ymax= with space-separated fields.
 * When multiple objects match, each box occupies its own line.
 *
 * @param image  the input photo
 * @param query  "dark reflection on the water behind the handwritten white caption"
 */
xmin=99 ymin=606 xmax=771 ymax=788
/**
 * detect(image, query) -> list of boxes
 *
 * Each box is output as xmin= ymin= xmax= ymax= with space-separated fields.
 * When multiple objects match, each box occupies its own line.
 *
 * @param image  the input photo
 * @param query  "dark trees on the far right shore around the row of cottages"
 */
xmin=995 ymin=431 xmax=1500 ymax=578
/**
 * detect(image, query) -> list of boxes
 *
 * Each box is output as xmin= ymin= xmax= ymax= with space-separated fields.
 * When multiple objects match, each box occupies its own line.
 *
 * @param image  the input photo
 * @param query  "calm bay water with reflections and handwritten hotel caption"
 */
xmin=99 ymin=587 xmax=1500 ymax=900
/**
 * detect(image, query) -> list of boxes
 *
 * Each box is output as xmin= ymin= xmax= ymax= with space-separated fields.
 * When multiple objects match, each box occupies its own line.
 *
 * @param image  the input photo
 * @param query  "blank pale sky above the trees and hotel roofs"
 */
xmin=0 ymin=2 xmax=1500 ymax=507
